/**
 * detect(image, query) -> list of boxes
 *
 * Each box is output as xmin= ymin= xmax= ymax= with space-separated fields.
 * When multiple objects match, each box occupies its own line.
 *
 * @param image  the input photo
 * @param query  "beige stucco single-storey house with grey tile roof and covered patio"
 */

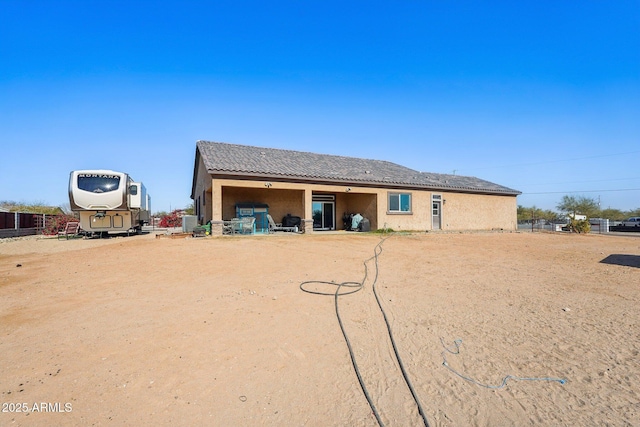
xmin=191 ymin=141 xmax=520 ymax=234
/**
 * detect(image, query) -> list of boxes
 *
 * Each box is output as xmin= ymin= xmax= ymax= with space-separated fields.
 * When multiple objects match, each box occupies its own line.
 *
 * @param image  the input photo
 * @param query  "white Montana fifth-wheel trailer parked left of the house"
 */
xmin=69 ymin=170 xmax=151 ymax=233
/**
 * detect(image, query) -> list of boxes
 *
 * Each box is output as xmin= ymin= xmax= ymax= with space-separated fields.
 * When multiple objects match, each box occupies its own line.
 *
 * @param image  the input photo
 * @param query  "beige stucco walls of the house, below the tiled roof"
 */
xmin=208 ymin=175 xmax=517 ymax=231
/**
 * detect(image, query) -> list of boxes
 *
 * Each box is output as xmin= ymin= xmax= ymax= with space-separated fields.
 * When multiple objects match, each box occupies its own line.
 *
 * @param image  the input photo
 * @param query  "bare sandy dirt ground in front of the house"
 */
xmin=0 ymin=233 xmax=640 ymax=427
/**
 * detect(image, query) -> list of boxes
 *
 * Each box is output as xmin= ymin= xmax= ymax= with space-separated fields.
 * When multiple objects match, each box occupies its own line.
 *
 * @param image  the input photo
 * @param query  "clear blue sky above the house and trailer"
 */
xmin=0 ymin=0 xmax=640 ymax=211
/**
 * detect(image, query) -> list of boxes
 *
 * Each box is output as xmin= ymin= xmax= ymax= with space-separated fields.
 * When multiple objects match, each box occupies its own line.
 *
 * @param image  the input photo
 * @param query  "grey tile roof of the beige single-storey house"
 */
xmin=196 ymin=141 xmax=520 ymax=195
